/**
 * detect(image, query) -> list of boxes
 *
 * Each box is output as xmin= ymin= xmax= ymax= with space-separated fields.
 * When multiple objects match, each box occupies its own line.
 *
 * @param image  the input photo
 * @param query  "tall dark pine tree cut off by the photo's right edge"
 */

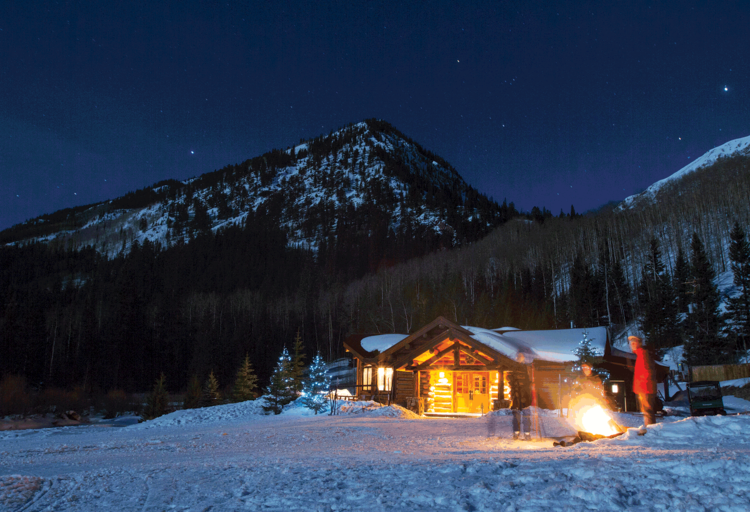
xmin=727 ymin=222 xmax=750 ymax=358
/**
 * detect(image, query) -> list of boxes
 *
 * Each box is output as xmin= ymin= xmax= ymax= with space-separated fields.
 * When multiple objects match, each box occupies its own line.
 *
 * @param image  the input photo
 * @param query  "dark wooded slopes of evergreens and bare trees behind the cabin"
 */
xmin=0 ymin=140 xmax=750 ymax=400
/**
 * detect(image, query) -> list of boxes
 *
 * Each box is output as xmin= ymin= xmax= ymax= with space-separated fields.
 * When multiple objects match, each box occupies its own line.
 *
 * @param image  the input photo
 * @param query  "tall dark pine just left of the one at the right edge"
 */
xmin=685 ymin=233 xmax=731 ymax=365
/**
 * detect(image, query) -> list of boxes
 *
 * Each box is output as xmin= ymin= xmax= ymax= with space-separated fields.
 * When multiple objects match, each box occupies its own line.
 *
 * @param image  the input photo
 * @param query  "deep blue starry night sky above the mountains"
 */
xmin=0 ymin=0 xmax=750 ymax=229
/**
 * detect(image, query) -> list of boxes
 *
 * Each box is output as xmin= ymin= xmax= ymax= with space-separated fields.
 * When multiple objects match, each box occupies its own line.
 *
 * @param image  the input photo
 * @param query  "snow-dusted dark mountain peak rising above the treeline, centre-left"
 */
xmin=2 ymin=120 xmax=497 ymax=257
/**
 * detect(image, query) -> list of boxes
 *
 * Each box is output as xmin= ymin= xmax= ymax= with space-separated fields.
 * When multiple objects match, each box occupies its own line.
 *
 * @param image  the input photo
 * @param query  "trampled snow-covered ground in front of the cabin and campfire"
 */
xmin=0 ymin=399 xmax=750 ymax=511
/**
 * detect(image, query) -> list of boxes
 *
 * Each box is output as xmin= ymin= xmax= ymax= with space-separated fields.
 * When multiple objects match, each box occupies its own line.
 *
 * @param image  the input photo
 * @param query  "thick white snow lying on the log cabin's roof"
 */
xmin=360 ymin=326 xmax=607 ymax=363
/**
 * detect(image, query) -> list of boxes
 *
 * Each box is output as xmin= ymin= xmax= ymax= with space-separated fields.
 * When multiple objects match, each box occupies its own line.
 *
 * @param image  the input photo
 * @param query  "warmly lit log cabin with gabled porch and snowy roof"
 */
xmin=344 ymin=316 xmax=666 ymax=415
